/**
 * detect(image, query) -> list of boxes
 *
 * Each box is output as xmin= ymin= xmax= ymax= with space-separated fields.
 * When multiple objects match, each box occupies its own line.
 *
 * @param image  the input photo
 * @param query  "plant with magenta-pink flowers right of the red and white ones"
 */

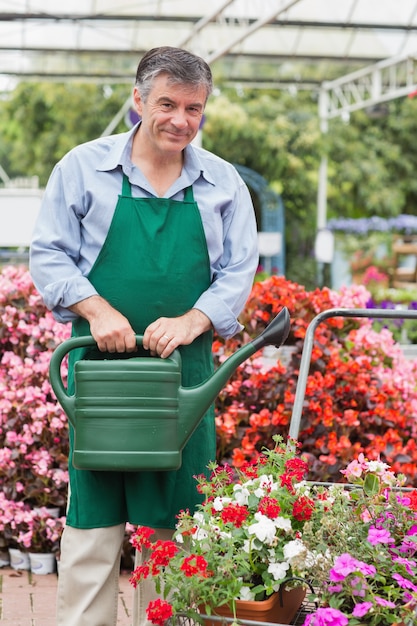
xmin=302 ymin=454 xmax=417 ymax=626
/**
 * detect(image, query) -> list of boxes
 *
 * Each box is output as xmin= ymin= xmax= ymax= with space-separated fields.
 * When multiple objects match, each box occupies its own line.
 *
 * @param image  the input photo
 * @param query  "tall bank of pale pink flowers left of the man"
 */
xmin=0 ymin=266 xmax=69 ymax=548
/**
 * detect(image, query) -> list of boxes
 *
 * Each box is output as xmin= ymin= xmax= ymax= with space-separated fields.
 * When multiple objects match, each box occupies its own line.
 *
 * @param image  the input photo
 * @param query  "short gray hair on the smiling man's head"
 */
xmin=135 ymin=46 xmax=213 ymax=102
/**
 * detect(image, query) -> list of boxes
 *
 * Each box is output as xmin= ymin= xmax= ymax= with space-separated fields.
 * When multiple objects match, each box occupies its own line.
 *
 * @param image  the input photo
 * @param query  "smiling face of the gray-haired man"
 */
xmin=133 ymin=74 xmax=207 ymax=153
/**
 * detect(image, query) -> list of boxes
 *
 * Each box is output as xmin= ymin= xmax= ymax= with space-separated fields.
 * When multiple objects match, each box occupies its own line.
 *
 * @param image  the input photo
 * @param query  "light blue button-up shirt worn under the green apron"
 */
xmin=30 ymin=122 xmax=258 ymax=337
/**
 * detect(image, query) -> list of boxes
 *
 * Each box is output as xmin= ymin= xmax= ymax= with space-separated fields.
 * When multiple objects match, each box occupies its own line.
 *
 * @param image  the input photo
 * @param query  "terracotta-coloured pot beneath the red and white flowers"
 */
xmin=201 ymin=587 xmax=306 ymax=626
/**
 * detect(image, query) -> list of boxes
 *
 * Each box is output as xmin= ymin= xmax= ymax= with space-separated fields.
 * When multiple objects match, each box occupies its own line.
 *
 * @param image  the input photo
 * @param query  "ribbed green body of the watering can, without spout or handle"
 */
xmin=69 ymin=352 xmax=181 ymax=471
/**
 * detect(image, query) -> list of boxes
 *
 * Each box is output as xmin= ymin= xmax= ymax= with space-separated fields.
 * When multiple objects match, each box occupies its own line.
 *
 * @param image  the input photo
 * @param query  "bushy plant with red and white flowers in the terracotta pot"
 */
xmin=131 ymin=437 xmax=314 ymax=624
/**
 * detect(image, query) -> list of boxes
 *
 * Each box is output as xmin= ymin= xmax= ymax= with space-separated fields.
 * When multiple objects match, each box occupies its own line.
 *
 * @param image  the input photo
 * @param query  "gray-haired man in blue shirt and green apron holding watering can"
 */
xmin=31 ymin=47 xmax=258 ymax=626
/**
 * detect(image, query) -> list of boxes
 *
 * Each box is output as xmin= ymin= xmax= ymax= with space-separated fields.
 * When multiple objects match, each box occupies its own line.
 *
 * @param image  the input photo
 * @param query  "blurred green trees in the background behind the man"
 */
xmin=0 ymin=82 xmax=417 ymax=288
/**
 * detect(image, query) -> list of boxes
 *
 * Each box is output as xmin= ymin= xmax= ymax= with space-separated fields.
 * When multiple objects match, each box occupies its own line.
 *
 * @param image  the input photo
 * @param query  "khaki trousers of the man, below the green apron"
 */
xmin=57 ymin=524 xmax=173 ymax=626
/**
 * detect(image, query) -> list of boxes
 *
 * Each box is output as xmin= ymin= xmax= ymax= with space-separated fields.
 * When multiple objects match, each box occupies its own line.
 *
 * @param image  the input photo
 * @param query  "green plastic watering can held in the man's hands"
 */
xmin=50 ymin=308 xmax=290 ymax=471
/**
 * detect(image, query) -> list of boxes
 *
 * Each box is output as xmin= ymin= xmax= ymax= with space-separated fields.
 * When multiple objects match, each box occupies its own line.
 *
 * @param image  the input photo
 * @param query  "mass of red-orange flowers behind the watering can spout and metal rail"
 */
xmin=214 ymin=276 xmax=417 ymax=484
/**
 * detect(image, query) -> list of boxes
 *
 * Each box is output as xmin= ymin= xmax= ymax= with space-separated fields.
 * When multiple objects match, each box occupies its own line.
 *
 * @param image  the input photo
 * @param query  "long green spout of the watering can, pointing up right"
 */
xmin=179 ymin=307 xmax=291 ymax=447
